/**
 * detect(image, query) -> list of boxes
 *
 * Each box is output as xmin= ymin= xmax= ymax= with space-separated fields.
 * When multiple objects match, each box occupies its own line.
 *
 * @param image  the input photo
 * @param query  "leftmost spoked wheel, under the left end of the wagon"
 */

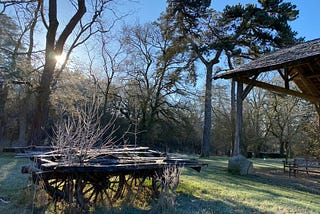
xmin=43 ymin=177 xmax=74 ymax=202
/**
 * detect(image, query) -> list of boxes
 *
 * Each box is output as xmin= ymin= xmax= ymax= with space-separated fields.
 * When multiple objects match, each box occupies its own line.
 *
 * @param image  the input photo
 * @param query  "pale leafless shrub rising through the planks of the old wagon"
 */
xmin=52 ymin=102 xmax=119 ymax=163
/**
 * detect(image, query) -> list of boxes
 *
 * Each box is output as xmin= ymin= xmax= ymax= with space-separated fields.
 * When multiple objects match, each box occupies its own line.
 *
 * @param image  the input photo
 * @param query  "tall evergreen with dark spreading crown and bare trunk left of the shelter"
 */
xmin=161 ymin=0 xmax=298 ymax=156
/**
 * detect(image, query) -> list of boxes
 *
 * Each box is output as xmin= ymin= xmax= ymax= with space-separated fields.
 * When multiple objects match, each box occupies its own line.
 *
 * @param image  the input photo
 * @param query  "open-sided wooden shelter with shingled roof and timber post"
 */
xmin=215 ymin=38 xmax=320 ymax=159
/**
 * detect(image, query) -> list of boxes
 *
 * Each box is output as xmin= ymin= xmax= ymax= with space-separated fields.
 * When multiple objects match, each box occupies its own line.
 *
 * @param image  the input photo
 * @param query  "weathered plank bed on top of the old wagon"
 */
xmin=25 ymin=147 xmax=204 ymax=177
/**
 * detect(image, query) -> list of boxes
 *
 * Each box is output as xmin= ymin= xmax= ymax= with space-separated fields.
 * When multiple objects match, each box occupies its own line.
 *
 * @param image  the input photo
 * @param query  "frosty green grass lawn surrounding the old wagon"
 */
xmin=0 ymin=153 xmax=320 ymax=214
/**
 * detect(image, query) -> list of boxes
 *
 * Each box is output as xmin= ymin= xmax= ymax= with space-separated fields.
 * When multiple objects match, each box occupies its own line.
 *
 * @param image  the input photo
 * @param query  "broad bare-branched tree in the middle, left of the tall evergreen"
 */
xmin=120 ymin=24 xmax=195 ymax=144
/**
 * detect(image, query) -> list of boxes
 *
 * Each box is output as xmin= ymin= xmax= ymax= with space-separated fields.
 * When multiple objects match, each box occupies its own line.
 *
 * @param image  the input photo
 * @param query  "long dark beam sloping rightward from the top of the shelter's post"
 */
xmin=236 ymin=77 xmax=320 ymax=103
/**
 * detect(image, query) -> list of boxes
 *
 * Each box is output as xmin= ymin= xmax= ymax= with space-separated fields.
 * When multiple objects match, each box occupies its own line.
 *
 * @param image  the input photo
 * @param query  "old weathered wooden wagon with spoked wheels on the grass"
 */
xmin=22 ymin=146 xmax=206 ymax=209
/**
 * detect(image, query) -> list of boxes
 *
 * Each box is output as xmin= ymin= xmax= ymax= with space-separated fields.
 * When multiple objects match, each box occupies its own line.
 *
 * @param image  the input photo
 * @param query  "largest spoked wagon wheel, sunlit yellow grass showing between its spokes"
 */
xmin=75 ymin=175 xmax=124 ymax=208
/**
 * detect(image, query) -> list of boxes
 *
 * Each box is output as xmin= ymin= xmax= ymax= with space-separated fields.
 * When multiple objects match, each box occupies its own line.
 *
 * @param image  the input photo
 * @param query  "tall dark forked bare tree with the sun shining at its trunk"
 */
xmin=32 ymin=0 xmax=116 ymax=144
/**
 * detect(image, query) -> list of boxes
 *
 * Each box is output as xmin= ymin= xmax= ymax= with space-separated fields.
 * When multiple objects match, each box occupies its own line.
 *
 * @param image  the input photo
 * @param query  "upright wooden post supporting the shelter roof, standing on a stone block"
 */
xmin=233 ymin=82 xmax=243 ymax=156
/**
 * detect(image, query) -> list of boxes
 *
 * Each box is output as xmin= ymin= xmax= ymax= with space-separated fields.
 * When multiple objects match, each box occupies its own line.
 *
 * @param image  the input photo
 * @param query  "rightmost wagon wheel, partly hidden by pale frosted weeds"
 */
xmin=152 ymin=167 xmax=179 ymax=195
